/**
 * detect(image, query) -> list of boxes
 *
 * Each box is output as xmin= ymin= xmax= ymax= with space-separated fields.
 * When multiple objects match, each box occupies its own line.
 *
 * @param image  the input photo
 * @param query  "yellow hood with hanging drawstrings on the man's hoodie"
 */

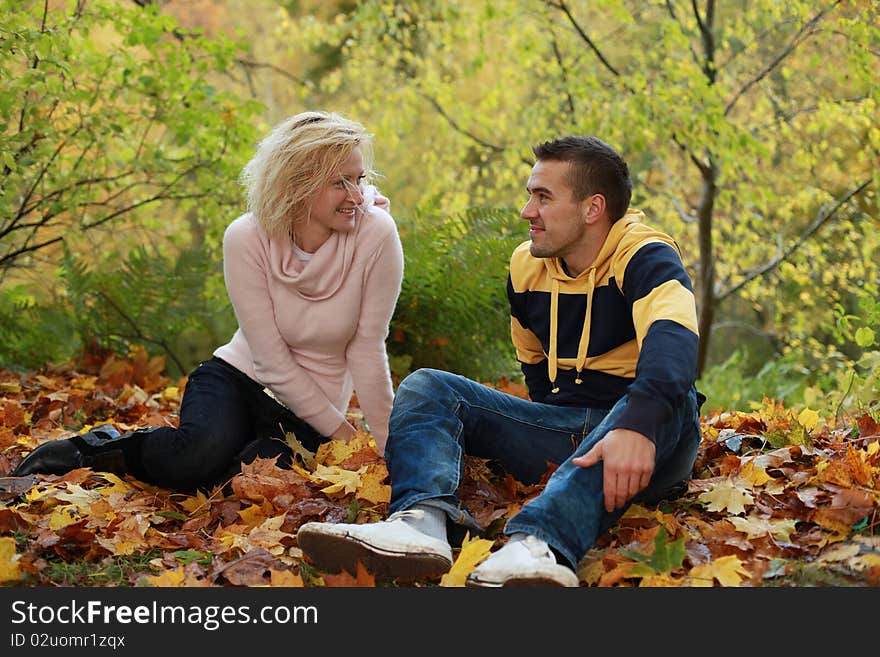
xmin=544 ymin=209 xmax=679 ymax=393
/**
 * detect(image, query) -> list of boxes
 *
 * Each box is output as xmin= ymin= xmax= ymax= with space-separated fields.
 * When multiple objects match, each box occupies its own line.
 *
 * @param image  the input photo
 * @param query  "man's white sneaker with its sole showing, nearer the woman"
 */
xmin=296 ymin=509 xmax=452 ymax=579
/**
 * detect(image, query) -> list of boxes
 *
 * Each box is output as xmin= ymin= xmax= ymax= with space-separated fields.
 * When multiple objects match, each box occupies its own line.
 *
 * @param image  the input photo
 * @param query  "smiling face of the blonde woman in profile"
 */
xmin=295 ymin=147 xmax=364 ymax=252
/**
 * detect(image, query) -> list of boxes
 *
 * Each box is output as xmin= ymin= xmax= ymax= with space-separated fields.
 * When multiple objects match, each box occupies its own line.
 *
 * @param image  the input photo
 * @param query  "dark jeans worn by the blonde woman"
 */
xmin=136 ymin=357 xmax=328 ymax=490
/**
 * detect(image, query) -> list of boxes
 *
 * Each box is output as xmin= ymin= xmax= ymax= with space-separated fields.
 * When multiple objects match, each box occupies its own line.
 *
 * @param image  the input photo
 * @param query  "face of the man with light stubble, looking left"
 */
xmin=519 ymin=160 xmax=587 ymax=259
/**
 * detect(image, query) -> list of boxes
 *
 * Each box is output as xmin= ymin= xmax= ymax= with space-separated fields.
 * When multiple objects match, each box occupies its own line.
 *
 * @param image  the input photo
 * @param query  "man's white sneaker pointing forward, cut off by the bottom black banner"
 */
xmin=466 ymin=535 xmax=579 ymax=587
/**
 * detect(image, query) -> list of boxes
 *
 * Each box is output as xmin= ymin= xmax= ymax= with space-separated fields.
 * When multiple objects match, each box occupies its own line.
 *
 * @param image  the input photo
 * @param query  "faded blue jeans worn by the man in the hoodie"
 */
xmin=385 ymin=369 xmax=702 ymax=567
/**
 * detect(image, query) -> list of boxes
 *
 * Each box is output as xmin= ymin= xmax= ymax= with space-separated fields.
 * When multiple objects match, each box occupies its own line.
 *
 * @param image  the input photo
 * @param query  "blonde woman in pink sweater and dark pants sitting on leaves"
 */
xmin=14 ymin=112 xmax=403 ymax=490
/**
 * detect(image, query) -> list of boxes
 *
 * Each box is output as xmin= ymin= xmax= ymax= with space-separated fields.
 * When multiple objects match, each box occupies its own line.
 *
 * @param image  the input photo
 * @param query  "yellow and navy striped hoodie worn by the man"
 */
xmin=507 ymin=209 xmax=698 ymax=440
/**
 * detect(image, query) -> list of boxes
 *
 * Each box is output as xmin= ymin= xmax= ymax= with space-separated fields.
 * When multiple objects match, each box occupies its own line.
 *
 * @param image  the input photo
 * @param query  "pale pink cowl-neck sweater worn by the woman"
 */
xmin=214 ymin=199 xmax=403 ymax=450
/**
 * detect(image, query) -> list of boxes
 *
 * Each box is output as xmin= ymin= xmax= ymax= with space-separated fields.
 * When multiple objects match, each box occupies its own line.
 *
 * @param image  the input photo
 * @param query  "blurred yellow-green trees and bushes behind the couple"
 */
xmin=0 ymin=0 xmax=880 ymax=416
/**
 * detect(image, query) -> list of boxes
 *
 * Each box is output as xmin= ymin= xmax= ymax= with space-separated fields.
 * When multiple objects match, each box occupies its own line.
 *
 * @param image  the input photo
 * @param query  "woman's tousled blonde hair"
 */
xmin=241 ymin=111 xmax=373 ymax=237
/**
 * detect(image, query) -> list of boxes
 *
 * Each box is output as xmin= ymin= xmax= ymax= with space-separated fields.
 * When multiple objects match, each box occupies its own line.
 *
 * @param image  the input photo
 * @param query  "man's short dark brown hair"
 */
xmin=532 ymin=136 xmax=632 ymax=223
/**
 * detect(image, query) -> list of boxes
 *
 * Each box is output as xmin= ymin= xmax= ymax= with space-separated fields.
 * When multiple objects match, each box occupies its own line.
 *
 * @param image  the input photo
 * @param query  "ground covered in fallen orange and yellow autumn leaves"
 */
xmin=0 ymin=350 xmax=880 ymax=587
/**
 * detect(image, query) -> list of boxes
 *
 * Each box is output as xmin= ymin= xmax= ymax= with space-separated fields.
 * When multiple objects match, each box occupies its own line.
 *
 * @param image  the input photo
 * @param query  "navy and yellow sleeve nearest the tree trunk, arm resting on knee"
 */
xmin=617 ymin=241 xmax=699 ymax=440
